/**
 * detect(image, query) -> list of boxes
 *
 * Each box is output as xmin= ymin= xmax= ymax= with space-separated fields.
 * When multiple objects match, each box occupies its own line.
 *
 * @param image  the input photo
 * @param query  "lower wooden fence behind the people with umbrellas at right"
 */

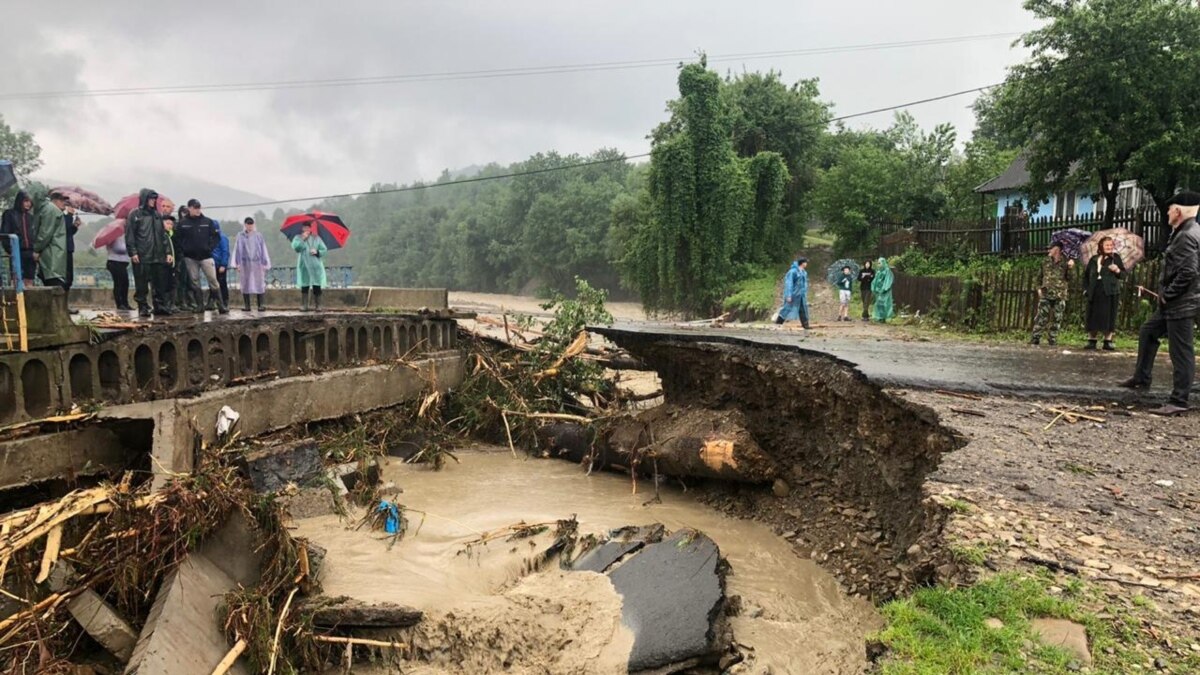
xmin=893 ymin=255 xmax=1160 ymax=330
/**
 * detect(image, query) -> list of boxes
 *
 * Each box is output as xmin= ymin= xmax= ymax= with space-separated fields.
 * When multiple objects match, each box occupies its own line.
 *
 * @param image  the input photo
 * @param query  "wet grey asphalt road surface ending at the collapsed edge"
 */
xmin=598 ymin=322 xmax=1171 ymax=402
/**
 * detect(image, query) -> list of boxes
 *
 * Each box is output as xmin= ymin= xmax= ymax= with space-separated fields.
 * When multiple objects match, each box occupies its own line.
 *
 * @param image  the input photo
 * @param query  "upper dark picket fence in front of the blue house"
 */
xmin=912 ymin=209 xmax=1170 ymax=257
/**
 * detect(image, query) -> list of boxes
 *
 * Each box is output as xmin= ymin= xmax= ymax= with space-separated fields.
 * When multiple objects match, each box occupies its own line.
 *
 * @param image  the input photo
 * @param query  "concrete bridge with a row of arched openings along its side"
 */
xmin=0 ymin=288 xmax=462 ymax=490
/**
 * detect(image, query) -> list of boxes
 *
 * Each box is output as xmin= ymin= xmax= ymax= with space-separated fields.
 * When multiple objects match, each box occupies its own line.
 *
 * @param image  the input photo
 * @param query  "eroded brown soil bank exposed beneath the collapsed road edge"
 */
xmin=601 ymin=330 xmax=961 ymax=599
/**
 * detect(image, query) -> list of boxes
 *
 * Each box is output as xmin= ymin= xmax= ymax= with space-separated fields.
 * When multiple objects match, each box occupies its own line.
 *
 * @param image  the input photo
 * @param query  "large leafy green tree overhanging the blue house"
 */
xmin=986 ymin=0 xmax=1200 ymax=223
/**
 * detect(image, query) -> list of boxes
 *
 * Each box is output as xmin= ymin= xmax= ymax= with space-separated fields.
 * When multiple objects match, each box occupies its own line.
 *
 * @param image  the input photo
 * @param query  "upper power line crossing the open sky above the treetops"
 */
xmin=0 ymin=32 xmax=1019 ymax=101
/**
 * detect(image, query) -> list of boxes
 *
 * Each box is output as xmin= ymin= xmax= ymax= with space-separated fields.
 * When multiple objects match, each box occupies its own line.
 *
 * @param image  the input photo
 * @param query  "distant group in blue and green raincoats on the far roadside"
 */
xmin=775 ymin=253 xmax=895 ymax=330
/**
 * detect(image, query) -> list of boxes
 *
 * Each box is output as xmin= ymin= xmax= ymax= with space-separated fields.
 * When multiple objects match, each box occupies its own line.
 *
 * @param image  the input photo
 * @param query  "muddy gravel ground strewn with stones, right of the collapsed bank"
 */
xmin=894 ymin=392 xmax=1200 ymax=650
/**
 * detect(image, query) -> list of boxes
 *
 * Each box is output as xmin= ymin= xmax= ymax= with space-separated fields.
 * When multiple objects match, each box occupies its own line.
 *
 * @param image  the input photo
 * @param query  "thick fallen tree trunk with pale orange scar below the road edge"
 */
xmin=538 ymin=405 xmax=778 ymax=483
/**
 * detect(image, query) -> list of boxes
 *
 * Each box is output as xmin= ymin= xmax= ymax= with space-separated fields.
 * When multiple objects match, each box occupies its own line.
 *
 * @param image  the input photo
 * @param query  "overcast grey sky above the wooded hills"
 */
xmin=0 ymin=0 xmax=1034 ymax=212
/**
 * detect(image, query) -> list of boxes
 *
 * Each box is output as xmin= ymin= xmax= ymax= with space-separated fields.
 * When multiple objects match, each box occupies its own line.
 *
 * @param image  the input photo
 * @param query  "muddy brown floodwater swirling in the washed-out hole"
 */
xmin=295 ymin=449 xmax=880 ymax=673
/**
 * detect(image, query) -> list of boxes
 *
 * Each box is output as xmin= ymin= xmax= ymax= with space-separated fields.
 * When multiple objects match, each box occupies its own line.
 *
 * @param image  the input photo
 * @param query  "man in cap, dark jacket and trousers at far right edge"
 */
xmin=1121 ymin=187 xmax=1200 ymax=414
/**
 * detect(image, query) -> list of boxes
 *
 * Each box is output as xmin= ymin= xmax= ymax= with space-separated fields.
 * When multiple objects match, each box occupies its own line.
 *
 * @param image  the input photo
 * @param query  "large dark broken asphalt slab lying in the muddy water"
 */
xmin=608 ymin=530 xmax=725 ymax=671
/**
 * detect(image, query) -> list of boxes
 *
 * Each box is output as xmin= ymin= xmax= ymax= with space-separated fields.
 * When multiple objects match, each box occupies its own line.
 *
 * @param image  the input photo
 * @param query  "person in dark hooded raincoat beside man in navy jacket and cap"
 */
xmin=125 ymin=187 xmax=175 ymax=318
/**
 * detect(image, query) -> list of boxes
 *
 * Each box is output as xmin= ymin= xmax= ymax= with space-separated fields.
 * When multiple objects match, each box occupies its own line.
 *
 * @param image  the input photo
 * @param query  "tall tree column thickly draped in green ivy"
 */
xmin=625 ymin=60 xmax=790 ymax=313
